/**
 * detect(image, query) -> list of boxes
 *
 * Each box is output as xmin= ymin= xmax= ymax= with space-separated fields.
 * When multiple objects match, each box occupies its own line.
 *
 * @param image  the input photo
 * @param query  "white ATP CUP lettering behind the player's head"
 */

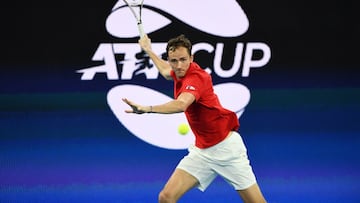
xmin=77 ymin=42 xmax=271 ymax=80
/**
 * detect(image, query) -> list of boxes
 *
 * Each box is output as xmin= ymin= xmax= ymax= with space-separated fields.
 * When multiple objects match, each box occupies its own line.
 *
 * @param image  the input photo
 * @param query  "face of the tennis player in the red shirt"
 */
xmin=168 ymin=47 xmax=193 ymax=78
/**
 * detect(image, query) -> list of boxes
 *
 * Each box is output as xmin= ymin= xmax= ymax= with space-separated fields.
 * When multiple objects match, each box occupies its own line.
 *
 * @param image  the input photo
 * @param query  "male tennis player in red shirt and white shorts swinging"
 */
xmin=123 ymin=35 xmax=265 ymax=203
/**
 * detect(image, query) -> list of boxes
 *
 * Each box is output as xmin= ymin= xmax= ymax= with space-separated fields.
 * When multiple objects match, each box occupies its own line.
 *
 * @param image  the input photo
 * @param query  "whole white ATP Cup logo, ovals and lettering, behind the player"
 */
xmin=77 ymin=0 xmax=271 ymax=149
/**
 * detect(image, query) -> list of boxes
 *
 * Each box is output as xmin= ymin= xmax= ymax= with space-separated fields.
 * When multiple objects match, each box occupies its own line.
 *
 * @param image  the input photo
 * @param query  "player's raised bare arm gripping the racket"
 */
xmin=139 ymin=35 xmax=172 ymax=80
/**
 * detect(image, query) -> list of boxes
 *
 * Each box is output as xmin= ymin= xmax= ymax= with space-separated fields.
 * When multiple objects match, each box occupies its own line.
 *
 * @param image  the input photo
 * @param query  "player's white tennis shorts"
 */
xmin=176 ymin=131 xmax=256 ymax=191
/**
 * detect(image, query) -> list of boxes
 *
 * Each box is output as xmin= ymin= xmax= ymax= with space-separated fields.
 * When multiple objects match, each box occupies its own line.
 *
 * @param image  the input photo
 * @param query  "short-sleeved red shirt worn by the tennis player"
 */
xmin=171 ymin=62 xmax=239 ymax=148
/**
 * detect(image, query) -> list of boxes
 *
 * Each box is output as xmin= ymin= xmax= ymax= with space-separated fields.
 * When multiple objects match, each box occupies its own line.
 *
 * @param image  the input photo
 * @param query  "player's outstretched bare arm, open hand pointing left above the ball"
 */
xmin=123 ymin=92 xmax=196 ymax=114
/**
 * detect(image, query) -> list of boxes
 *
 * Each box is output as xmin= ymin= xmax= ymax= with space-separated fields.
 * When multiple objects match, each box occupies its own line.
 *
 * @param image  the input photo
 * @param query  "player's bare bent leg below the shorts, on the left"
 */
xmin=159 ymin=168 xmax=199 ymax=203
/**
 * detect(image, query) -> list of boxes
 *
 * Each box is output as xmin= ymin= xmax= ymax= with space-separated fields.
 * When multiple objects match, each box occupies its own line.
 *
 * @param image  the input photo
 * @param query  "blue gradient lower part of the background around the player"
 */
xmin=0 ymin=89 xmax=360 ymax=203
